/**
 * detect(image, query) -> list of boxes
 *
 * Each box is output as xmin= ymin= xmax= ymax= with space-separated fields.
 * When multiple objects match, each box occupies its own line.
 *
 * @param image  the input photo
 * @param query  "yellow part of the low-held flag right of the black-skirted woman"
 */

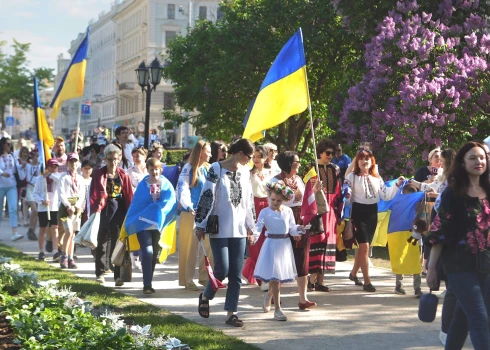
xmin=388 ymin=231 xmax=422 ymax=275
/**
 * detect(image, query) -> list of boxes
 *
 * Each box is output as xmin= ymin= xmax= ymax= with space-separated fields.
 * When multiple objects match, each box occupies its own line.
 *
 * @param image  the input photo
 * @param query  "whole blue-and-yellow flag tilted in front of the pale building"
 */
xmin=50 ymin=27 xmax=90 ymax=119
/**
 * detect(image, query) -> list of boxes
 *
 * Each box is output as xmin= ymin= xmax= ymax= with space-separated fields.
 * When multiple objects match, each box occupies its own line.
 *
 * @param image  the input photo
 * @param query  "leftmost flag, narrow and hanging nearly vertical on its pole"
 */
xmin=34 ymin=77 xmax=54 ymax=172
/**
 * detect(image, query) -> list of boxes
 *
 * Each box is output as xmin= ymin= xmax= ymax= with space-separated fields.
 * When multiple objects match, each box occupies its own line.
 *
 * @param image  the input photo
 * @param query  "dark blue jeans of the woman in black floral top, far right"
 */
xmin=445 ymin=272 xmax=490 ymax=350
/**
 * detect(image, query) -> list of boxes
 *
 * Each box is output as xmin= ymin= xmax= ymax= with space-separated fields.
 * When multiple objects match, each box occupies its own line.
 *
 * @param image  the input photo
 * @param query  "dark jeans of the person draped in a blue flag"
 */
xmin=137 ymin=230 xmax=160 ymax=287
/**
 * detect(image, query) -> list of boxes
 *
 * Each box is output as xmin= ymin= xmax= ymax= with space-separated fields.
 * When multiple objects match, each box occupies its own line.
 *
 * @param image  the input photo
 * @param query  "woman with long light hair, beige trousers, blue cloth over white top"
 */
xmin=177 ymin=140 xmax=214 ymax=291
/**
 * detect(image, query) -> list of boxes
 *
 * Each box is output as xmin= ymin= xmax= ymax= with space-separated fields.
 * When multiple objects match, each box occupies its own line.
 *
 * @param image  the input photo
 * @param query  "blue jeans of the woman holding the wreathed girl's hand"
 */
xmin=204 ymin=238 xmax=247 ymax=312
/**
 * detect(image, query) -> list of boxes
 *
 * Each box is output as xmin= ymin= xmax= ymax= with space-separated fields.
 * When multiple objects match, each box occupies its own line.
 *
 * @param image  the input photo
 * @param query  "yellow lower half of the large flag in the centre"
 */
xmin=243 ymin=66 xmax=308 ymax=142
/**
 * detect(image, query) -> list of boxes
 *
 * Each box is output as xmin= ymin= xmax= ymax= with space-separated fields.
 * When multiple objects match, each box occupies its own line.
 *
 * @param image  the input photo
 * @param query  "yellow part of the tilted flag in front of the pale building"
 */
xmin=51 ymin=60 xmax=87 ymax=119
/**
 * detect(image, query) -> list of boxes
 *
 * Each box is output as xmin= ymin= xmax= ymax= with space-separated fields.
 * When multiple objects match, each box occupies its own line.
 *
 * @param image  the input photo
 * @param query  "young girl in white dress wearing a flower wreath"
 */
xmin=254 ymin=182 xmax=306 ymax=321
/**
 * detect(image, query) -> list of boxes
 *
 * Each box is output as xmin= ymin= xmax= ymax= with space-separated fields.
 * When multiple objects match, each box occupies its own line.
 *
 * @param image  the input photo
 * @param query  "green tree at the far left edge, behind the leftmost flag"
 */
xmin=0 ymin=39 xmax=53 ymax=129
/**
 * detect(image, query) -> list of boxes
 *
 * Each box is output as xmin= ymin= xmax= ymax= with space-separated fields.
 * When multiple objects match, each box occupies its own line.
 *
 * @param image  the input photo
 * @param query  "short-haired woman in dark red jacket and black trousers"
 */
xmin=90 ymin=144 xmax=133 ymax=286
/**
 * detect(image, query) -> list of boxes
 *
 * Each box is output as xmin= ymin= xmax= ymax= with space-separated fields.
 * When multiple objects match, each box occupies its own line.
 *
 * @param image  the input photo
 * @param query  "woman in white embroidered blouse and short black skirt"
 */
xmin=344 ymin=150 xmax=404 ymax=292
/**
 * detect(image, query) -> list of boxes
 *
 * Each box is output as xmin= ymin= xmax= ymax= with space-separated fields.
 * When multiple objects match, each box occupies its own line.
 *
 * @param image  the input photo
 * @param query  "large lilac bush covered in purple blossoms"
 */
xmin=339 ymin=0 xmax=490 ymax=173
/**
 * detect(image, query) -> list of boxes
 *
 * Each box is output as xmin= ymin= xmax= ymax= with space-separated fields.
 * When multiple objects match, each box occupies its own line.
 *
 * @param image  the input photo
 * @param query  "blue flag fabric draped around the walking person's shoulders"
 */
xmin=125 ymin=175 xmax=177 ymax=235
